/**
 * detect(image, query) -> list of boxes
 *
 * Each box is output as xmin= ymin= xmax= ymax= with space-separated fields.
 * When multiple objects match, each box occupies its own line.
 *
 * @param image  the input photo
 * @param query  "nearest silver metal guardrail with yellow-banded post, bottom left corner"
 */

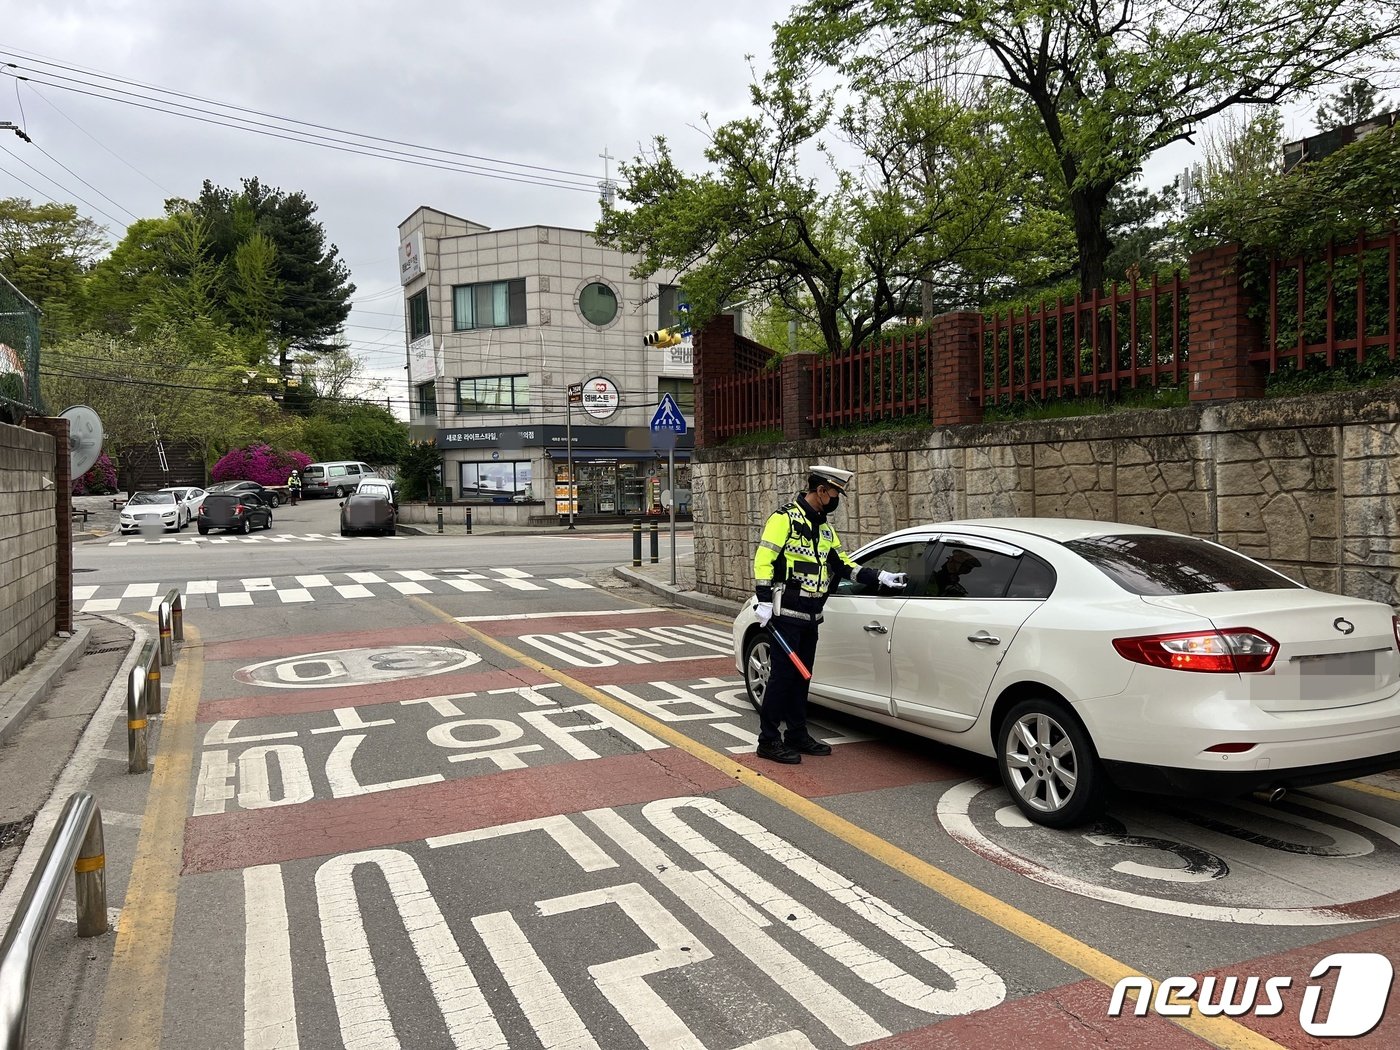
xmin=0 ymin=791 xmax=106 ymax=1050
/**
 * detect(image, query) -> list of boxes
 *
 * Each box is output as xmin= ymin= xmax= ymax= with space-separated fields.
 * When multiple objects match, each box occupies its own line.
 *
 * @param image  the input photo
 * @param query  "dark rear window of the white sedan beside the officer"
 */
xmin=1065 ymin=532 xmax=1302 ymax=595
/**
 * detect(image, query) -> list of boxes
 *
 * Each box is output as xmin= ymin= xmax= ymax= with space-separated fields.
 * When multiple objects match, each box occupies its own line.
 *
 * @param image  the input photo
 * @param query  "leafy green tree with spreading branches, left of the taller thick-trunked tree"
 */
xmin=596 ymin=76 xmax=1013 ymax=351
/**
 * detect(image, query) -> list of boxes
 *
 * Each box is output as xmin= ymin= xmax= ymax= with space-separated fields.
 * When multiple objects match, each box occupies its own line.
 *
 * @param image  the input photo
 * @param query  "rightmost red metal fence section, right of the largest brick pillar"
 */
xmin=1249 ymin=230 xmax=1400 ymax=372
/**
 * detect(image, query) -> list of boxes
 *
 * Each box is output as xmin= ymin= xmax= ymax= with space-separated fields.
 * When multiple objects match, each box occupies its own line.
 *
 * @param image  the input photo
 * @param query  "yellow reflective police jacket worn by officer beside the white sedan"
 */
xmin=753 ymin=497 xmax=878 ymax=623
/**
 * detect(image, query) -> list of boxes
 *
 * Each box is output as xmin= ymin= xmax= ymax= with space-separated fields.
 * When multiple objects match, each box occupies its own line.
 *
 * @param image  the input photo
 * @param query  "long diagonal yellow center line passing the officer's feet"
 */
xmin=410 ymin=598 xmax=1284 ymax=1050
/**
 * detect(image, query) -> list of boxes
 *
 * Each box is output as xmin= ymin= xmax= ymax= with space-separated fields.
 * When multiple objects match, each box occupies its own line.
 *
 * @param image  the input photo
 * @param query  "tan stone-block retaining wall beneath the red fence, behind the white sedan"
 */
xmin=692 ymin=389 xmax=1400 ymax=605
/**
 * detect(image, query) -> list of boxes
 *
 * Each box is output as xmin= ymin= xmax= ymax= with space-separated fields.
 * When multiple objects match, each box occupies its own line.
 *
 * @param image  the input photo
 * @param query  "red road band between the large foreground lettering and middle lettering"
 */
xmin=183 ymin=748 xmax=734 ymax=874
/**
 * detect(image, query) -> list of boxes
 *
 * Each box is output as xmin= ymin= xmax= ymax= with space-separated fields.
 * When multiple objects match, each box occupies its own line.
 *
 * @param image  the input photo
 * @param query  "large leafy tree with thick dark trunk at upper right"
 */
xmin=776 ymin=0 xmax=1400 ymax=293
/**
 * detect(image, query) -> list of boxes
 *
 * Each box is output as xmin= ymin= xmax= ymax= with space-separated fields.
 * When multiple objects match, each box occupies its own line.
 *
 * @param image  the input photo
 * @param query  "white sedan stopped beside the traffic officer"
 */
xmin=734 ymin=518 xmax=1400 ymax=827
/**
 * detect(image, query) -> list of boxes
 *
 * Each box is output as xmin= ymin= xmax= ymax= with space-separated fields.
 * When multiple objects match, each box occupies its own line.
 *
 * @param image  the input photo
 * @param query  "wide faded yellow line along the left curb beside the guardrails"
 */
xmin=92 ymin=623 xmax=204 ymax=1050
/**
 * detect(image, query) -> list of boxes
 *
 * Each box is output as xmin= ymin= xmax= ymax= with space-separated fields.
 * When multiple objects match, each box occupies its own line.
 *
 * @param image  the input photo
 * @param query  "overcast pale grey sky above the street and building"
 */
xmin=0 ymin=0 xmax=1344 ymax=414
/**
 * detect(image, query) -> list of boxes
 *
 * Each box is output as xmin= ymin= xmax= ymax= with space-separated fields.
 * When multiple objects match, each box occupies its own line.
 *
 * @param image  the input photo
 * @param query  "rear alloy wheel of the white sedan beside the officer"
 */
xmin=997 ymin=697 xmax=1103 ymax=827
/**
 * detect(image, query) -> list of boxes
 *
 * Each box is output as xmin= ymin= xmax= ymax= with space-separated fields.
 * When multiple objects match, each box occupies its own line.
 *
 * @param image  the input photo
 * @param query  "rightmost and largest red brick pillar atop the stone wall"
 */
xmin=1187 ymin=245 xmax=1267 ymax=400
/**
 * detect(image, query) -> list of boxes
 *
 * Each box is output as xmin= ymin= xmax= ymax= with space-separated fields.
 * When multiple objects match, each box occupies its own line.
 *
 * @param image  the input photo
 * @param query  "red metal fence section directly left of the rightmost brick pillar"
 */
xmin=979 ymin=273 xmax=1187 ymax=405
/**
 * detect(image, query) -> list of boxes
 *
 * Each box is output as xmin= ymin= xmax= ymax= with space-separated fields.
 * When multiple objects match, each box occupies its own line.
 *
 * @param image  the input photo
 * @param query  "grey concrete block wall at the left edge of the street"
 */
xmin=0 ymin=424 xmax=57 ymax=682
